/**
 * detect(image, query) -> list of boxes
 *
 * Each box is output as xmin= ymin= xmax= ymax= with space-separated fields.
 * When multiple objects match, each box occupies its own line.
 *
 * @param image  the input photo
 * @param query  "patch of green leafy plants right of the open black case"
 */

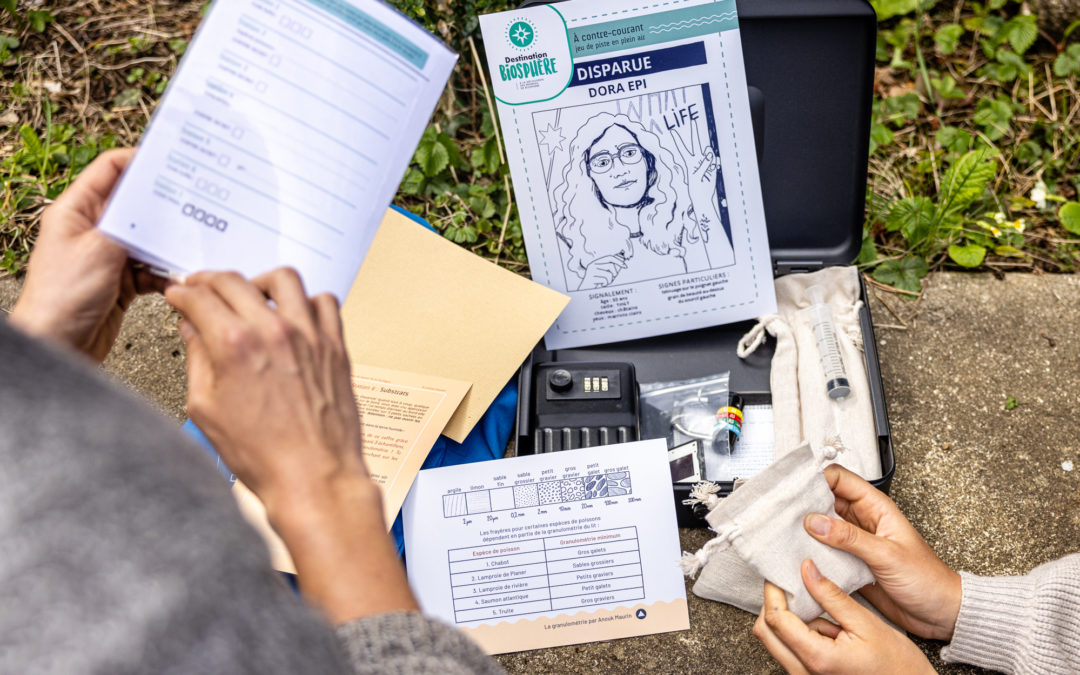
xmin=859 ymin=0 xmax=1080 ymax=293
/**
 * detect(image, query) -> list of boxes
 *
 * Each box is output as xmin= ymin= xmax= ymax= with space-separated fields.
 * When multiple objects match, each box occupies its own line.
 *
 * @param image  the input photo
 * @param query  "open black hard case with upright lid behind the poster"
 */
xmin=515 ymin=0 xmax=895 ymax=527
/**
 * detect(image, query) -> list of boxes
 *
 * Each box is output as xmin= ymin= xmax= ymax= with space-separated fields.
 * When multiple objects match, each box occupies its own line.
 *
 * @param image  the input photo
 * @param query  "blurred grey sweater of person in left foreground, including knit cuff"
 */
xmin=0 ymin=321 xmax=500 ymax=674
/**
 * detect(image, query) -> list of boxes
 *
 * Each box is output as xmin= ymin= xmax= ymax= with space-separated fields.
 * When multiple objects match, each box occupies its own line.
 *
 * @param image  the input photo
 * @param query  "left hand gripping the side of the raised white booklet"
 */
xmin=11 ymin=148 xmax=153 ymax=363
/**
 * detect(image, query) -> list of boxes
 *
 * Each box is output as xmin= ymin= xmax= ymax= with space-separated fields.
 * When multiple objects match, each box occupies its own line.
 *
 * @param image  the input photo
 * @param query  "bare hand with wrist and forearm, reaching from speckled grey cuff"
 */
xmin=165 ymin=269 xmax=417 ymax=621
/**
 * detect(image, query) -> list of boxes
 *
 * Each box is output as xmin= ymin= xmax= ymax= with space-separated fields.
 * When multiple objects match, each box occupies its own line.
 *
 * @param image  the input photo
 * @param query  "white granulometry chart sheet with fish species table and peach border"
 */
xmin=403 ymin=440 xmax=690 ymax=653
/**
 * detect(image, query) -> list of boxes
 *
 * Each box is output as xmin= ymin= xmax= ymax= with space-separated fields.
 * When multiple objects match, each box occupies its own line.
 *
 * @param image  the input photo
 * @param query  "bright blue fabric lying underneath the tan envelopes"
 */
xmin=183 ymin=206 xmax=517 ymax=558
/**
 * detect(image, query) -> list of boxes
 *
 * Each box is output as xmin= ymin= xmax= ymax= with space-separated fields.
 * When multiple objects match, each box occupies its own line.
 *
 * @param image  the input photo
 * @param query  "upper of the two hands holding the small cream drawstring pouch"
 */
xmin=804 ymin=464 xmax=961 ymax=640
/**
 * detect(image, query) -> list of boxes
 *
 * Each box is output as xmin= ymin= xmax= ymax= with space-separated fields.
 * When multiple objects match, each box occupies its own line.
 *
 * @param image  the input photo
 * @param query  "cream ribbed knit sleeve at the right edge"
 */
xmin=942 ymin=553 xmax=1080 ymax=673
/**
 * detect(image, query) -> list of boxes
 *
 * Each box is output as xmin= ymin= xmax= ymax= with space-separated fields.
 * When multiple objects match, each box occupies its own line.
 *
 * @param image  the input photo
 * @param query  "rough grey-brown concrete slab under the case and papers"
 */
xmin=0 ymin=273 xmax=1080 ymax=674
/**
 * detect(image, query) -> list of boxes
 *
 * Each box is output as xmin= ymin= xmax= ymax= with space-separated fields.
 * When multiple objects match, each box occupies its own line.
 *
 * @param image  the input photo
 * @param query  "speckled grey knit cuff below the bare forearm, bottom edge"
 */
xmin=335 ymin=611 xmax=503 ymax=675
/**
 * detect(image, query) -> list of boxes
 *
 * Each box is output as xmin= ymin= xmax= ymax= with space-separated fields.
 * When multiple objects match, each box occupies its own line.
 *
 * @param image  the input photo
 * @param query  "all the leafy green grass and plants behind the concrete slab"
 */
xmin=0 ymin=0 xmax=1080 ymax=287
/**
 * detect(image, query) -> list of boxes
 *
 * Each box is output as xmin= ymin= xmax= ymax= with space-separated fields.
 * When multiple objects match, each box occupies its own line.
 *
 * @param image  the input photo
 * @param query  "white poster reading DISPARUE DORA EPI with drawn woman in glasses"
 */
xmin=481 ymin=0 xmax=775 ymax=349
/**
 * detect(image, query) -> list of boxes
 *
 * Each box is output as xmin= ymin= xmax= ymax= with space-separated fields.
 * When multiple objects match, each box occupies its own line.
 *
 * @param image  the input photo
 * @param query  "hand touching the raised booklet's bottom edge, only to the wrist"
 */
xmin=165 ymin=269 xmax=358 ymax=507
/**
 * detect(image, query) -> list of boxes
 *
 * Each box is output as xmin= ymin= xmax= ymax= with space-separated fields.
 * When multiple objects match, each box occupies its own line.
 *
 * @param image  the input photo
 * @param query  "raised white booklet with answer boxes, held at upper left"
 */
xmin=100 ymin=0 xmax=457 ymax=300
